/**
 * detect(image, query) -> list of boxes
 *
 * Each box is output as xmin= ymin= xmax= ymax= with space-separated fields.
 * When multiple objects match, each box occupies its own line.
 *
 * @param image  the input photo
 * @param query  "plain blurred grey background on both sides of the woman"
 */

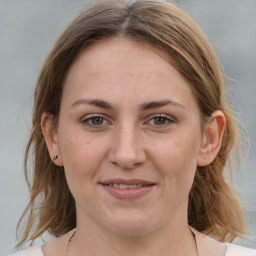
xmin=0 ymin=0 xmax=256 ymax=255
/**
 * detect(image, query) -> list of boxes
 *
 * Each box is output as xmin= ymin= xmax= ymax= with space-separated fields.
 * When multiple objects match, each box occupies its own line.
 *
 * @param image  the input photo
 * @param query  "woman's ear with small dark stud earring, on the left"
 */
xmin=41 ymin=113 xmax=63 ymax=166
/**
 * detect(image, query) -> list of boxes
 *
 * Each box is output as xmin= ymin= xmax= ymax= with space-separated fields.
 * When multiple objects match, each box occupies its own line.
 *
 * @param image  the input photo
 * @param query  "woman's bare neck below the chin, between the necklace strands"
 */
xmin=68 ymin=218 xmax=197 ymax=256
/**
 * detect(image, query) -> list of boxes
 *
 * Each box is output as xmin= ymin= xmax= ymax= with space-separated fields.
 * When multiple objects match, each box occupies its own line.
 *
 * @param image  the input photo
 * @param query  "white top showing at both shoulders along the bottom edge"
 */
xmin=10 ymin=243 xmax=256 ymax=256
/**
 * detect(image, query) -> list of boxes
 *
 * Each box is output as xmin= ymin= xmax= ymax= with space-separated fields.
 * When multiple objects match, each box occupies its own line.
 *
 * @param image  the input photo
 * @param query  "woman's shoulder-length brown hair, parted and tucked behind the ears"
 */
xmin=18 ymin=0 xmax=245 ymax=245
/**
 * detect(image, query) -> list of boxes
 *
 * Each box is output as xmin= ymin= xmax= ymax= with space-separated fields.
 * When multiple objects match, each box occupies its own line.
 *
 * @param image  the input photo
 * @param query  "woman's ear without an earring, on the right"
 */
xmin=197 ymin=110 xmax=226 ymax=166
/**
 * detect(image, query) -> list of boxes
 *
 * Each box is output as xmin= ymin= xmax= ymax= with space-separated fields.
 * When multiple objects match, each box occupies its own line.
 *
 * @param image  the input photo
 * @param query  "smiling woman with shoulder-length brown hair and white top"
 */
xmin=11 ymin=0 xmax=256 ymax=256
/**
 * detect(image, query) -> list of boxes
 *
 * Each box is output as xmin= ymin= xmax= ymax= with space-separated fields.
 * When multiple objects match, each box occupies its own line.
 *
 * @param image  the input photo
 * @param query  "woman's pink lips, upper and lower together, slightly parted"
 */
xmin=99 ymin=179 xmax=156 ymax=200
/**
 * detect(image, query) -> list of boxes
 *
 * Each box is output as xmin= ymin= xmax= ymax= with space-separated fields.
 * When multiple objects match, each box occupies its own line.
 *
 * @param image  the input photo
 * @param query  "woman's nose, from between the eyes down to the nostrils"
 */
xmin=109 ymin=125 xmax=146 ymax=170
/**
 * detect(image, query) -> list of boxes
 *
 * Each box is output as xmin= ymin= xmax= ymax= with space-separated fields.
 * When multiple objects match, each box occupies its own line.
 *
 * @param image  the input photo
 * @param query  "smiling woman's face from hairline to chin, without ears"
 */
xmin=51 ymin=38 xmax=207 ymax=234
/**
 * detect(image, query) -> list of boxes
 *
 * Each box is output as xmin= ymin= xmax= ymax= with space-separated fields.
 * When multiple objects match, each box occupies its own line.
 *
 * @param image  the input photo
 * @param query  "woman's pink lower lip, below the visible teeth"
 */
xmin=102 ymin=185 xmax=155 ymax=199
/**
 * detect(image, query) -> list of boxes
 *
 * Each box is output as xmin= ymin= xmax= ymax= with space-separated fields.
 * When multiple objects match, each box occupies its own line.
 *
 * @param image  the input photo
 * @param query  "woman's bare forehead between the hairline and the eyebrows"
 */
xmin=63 ymin=38 xmax=198 ymax=111
